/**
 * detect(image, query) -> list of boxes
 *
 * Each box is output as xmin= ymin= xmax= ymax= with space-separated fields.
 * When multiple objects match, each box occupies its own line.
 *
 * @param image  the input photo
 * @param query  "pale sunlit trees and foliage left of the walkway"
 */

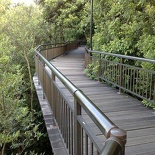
xmin=0 ymin=0 xmax=52 ymax=155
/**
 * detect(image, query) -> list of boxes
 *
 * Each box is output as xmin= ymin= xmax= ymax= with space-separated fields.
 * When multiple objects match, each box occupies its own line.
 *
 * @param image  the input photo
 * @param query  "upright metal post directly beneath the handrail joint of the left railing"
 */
xmin=74 ymin=99 xmax=82 ymax=155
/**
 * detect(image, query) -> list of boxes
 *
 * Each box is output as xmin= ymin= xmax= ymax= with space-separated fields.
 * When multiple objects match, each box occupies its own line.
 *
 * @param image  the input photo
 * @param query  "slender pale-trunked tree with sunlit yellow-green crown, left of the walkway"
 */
xmin=2 ymin=6 xmax=40 ymax=110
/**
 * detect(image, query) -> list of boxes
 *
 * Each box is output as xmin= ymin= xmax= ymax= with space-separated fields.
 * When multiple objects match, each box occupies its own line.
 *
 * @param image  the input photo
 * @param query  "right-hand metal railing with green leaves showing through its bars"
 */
xmin=85 ymin=49 xmax=155 ymax=106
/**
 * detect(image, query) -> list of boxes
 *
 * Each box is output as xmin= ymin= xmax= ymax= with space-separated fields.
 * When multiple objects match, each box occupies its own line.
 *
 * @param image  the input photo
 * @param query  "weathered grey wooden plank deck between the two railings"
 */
xmin=51 ymin=47 xmax=155 ymax=155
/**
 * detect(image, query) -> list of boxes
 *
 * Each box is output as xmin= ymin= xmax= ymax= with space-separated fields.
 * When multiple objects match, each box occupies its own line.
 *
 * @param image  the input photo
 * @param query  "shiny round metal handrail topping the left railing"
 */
xmin=35 ymin=41 xmax=126 ymax=155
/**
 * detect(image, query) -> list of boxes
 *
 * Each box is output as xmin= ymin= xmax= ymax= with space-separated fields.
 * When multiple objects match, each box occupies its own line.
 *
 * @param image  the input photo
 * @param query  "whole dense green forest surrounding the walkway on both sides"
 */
xmin=0 ymin=0 xmax=155 ymax=155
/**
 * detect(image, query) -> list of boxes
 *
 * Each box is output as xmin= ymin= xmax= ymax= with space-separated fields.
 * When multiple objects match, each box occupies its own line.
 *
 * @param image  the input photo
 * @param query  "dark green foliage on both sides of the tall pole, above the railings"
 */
xmin=40 ymin=0 xmax=155 ymax=58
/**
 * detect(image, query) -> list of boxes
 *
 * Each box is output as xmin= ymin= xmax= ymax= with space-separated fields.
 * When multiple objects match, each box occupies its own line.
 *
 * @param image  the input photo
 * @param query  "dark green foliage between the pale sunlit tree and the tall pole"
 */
xmin=40 ymin=0 xmax=89 ymax=43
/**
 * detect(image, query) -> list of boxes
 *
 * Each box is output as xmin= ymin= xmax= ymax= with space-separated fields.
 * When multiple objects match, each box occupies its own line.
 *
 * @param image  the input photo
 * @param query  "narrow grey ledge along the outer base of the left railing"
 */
xmin=33 ymin=75 xmax=68 ymax=155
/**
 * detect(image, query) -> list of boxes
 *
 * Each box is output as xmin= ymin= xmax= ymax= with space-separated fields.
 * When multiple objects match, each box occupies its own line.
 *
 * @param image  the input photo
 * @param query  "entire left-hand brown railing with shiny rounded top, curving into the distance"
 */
xmin=35 ymin=42 xmax=126 ymax=155
